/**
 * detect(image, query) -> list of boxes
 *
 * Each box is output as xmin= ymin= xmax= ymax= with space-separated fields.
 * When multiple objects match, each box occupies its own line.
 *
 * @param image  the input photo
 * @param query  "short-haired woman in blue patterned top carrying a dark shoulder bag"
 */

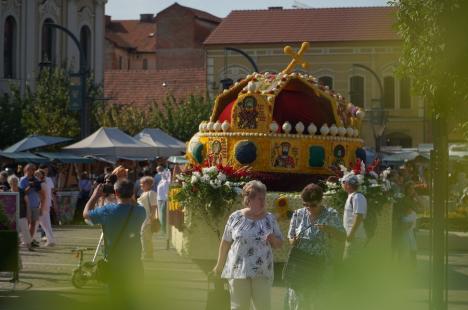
xmin=286 ymin=184 xmax=346 ymax=310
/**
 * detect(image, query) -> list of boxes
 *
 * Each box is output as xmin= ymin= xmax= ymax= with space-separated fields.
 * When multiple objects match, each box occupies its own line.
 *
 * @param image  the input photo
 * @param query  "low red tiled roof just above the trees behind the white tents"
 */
xmin=104 ymin=68 xmax=206 ymax=106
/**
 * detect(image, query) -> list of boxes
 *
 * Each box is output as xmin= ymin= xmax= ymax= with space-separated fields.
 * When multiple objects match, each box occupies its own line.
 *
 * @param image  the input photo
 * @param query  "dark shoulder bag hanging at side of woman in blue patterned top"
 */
xmin=283 ymin=224 xmax=325 ymax=288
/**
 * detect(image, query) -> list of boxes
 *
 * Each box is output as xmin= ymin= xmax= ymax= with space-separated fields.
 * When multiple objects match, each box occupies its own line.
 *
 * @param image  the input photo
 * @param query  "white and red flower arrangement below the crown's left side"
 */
xmin=175 ymin=162 xmax=250 ymax=237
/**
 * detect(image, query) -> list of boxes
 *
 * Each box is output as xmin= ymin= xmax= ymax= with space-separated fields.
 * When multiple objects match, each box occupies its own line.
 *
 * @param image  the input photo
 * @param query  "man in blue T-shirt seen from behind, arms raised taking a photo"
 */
xmin=83 ymin=179 xmax=146 ymax=309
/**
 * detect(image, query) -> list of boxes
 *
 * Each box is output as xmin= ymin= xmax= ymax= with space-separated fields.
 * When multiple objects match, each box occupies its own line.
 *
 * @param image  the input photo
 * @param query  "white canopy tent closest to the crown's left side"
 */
xmin=134 ymin=128 xmax=187 ymax=157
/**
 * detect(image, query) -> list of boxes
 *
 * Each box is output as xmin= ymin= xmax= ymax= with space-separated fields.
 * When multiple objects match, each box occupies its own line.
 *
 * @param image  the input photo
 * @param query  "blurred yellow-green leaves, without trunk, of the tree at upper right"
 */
xmin=392 ymin=0 xmax=468 ymax=136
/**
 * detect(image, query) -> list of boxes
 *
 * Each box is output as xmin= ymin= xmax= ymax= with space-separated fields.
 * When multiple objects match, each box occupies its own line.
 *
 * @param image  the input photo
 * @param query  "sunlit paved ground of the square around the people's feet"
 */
xmin=0 ymin=226 xmax=468 ymax=310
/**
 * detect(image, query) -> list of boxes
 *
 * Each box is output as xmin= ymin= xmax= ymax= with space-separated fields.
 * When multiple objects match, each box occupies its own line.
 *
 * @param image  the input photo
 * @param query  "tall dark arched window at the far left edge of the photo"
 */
xmin=3 ymin=16 xmax=17 ymax=79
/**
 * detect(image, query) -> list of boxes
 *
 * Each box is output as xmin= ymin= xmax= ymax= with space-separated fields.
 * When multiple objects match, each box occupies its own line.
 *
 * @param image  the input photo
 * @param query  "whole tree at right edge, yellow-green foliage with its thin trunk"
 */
xmin=393 ymin=0 xmax=468 ymax=309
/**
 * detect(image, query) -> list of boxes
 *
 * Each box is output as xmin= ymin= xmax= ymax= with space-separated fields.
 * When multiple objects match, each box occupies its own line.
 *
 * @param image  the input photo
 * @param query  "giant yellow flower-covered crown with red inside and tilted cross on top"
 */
xmin=187 ymin=42 xmax=365 ymax=189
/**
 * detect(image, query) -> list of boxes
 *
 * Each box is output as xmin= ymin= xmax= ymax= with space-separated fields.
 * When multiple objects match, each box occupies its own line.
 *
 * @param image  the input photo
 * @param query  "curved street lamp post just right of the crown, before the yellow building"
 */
xmin=352 ymin=64 xmax=387 ymax=154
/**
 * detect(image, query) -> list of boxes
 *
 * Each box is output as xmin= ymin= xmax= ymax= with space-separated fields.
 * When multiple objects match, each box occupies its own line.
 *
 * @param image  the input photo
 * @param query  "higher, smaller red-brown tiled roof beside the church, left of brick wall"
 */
xmin=106 ymin=20 xmax=156 ymax=52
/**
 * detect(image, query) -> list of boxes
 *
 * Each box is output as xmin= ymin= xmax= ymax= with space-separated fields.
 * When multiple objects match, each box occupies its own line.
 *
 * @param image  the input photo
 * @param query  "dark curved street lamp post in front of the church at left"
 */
xmin=44 ymin=23 xmax=90 ymax=139
